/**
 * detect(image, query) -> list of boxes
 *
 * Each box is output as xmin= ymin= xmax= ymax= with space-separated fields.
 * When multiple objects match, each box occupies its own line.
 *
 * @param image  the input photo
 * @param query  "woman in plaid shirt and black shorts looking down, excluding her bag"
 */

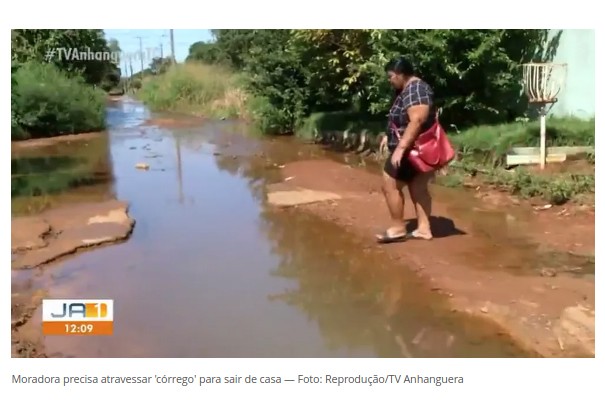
xmin=376 ymin=57 xmax=436 ymax=243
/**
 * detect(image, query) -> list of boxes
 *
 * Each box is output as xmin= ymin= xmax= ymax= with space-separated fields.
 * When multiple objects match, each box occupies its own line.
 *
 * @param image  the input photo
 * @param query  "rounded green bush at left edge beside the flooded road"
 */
xmin=11 ymin=62 xmax=105 ymax=140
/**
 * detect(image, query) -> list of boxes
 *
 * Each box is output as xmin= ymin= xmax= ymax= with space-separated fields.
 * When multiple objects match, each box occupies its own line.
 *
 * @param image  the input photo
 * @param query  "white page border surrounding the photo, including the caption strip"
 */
xmin=0 ymin=0 xmax=605 ymax=404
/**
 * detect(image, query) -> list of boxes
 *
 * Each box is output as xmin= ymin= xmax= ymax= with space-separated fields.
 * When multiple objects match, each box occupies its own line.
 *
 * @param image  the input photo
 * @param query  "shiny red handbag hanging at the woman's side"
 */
xmin=391 ymin=116 xmax=456 ymax=173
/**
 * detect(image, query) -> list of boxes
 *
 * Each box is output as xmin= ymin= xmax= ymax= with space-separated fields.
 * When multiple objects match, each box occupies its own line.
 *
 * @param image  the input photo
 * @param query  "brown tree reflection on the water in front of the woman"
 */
xmin=211 ymin=147 xmax=527 ymax=357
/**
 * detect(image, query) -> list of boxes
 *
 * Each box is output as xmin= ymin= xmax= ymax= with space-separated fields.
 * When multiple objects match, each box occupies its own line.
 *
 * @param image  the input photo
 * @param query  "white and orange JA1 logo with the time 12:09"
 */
xmin=42 ymin=299 xmax=113 ymax=335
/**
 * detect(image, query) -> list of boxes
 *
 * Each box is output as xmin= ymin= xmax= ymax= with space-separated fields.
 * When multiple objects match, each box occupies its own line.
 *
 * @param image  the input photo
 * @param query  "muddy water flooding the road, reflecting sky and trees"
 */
xmin=13 ymin=99 xmax=528 ymax=357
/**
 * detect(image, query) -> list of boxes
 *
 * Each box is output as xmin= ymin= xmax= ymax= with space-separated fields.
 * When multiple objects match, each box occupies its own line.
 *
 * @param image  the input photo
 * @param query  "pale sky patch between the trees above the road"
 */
xmin=104 ymin=29 xmax=212 ymax=73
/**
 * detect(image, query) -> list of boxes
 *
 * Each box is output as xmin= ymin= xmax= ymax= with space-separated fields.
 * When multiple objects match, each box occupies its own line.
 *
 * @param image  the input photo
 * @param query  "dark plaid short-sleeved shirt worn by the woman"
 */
xmin=387 ymin=80 xmax=436 ymax=151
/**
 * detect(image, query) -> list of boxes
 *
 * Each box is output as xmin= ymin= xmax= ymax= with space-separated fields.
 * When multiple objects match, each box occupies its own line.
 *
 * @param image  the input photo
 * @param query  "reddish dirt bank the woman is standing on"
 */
xmin=274 ymin=160 xmax=595 ymax=357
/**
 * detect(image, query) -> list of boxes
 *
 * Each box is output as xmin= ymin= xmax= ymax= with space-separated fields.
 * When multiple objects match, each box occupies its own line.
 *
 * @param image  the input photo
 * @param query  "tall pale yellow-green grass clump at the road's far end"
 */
xmin=138 ymin=63 xmax=247 ymax=118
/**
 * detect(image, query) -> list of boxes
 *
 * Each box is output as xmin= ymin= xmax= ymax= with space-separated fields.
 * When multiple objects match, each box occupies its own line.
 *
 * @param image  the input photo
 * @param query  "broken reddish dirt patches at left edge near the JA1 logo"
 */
xmin=11 ymin=200 xmax=135 ymax=357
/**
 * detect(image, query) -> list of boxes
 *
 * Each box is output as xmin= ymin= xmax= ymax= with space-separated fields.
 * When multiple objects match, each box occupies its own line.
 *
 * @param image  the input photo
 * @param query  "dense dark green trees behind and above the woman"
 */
xmin=190 ymin=29 xmax=558 ymax=133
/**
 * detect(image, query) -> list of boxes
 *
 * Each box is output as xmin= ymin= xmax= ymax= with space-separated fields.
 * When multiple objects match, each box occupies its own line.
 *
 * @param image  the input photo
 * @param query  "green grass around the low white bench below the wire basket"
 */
xmin=432 ymin=118 xmax=595 ymax=205
